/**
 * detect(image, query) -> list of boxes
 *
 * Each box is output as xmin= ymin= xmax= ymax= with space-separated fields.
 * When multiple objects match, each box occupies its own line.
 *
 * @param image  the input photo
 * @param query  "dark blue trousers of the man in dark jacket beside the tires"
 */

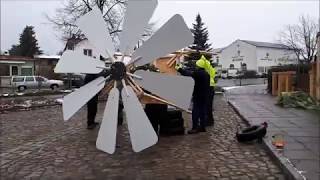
xmin=192 ymin=100 xmax=207 ymax=129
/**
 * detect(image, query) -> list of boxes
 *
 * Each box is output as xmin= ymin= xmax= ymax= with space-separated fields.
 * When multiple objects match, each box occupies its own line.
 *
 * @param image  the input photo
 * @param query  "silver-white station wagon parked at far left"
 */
xmin=11 ymin=76 xmax=63 ymax=91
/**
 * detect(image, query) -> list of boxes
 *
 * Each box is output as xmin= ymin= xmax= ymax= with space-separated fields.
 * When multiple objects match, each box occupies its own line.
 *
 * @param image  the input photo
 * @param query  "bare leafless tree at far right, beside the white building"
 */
xmin=279 ymin=16 xmax=319 ymax=63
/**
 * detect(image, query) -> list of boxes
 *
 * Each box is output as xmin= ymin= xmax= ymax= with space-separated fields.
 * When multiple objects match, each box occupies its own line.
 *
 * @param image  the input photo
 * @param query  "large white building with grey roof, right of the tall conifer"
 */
xmin=213 ymin=39 xmax=298 ymax=73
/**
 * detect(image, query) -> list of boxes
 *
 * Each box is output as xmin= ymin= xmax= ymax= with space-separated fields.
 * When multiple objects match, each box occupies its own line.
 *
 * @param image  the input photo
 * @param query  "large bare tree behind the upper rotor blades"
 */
xmin=46 ymin=0 xmax=154 ymax=48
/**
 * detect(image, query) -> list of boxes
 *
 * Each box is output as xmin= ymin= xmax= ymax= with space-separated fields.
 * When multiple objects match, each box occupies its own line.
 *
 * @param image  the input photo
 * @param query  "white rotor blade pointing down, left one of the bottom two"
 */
xmin=96 ymin=88 xmax=119 ymax=154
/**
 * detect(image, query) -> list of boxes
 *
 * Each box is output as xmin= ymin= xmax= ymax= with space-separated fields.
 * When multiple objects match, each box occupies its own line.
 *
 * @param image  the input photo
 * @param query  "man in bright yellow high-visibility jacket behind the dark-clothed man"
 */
xmin=199 ymin=55 xmax=216 ymax=126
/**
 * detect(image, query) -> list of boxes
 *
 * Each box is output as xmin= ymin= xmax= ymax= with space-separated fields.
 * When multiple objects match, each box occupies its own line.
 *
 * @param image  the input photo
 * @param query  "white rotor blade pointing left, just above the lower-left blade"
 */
xmin=54 ymin=50 xmax=105 ymax=74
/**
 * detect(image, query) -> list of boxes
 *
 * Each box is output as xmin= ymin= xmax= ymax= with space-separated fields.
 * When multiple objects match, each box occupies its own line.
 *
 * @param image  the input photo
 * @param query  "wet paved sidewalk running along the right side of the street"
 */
xmin=226 ymin=85 xmax=320 ymax=180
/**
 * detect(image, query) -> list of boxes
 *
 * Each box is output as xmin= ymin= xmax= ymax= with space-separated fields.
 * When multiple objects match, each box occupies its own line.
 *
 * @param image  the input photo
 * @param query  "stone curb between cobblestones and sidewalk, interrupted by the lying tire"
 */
xmin=228 ymin=100 xmax=306 ymax=180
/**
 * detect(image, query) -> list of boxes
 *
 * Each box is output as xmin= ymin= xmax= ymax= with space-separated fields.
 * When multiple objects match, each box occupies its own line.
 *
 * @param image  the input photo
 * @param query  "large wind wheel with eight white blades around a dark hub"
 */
xmin=55 ymin=0 xmax=194 ymax=154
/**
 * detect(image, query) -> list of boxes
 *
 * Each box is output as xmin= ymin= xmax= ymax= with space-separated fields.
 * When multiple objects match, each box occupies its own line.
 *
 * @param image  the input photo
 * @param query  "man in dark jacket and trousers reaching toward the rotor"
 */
xmin=176 ymin=60 xmax=210 ymax=134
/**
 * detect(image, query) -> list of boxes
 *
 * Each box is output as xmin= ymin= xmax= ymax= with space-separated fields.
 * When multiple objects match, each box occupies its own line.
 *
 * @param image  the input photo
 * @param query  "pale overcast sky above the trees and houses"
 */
xmin=0 ymin=0 xmax=319 ymax=54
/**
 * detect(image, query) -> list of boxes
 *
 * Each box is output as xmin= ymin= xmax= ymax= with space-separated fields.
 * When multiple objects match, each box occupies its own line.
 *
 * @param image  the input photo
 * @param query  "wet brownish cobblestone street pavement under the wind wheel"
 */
xmin=0 ymin=96 xmax=284 ymax=180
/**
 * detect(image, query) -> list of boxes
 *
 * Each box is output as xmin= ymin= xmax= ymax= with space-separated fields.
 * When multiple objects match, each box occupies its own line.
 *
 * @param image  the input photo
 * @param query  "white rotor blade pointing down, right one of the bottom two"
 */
xmin=121 ymin=86 xmax=158 ymax=152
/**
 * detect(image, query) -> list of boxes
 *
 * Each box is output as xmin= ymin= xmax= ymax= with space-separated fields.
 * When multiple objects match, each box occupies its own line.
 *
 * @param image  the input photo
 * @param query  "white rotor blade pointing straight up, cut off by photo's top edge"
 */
xmin=120 ymin=0 xmax=158 ymax=55
